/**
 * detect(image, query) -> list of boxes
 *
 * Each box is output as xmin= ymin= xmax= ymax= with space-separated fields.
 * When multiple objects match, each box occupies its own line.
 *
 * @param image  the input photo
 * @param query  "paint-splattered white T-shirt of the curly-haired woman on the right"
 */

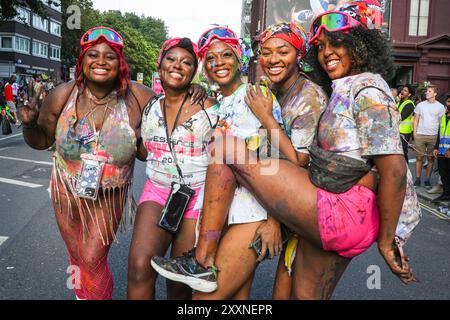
xmin=318 ymin=73 xmax=421 ymax=240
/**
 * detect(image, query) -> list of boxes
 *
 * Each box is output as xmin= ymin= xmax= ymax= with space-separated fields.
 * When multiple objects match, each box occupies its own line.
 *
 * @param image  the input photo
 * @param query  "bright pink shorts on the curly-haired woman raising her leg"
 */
xmin=317 ymin=185 xmax=380 ymax=258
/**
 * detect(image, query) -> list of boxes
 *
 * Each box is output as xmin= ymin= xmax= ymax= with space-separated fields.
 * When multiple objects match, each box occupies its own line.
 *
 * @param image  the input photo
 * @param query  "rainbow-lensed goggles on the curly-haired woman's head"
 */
xmin=309 ymin=11 xmax=362 ymax=44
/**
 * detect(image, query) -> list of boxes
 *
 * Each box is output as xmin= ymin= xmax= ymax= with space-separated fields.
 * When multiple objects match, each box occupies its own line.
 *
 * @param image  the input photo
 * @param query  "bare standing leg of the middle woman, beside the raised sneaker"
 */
xmin=193 ymin=221 xmax=263 ymax=300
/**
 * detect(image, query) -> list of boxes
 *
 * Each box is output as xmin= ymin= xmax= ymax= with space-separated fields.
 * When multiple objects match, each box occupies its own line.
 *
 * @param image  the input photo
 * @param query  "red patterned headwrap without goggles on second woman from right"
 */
xmin=259 ymin=22 xmax=310 ymax=59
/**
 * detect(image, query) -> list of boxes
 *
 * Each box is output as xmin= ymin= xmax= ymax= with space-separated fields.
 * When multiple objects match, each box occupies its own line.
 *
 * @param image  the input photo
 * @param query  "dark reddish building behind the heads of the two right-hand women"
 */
xmin=246 ymin=0 xmax=450 ymax=93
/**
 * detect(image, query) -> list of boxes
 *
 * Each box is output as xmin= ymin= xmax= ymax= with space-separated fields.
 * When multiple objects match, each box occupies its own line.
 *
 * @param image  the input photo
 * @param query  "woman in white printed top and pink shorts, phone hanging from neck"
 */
xmin=128 ymin=38 xmax=218 ymax=299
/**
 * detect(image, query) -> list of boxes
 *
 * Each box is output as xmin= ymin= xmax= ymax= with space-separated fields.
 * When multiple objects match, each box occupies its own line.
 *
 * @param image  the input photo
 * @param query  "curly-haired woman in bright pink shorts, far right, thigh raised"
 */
xmin=153 ymin=0 xmax=421 ymax=299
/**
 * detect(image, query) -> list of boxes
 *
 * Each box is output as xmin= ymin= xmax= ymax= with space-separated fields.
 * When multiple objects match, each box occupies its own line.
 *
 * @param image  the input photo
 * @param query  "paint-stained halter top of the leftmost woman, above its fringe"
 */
xmin=55 ymin=88 xmax=136 ymax=188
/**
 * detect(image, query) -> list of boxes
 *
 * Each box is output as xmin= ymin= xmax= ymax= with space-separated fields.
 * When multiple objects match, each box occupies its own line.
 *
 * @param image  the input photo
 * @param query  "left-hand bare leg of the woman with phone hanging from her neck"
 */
xmin=127 ymin=201 xmax=172 ymax=300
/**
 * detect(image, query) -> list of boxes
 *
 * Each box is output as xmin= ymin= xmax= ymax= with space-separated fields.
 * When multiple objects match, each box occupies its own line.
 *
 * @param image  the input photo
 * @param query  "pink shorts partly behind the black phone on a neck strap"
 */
xmin=139 ymin=179 xmax=201 ymax=219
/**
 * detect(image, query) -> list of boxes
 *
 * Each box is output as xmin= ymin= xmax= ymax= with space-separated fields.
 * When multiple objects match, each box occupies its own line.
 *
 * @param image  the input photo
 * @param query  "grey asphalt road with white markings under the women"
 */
xmin=0 ymin=128 xmax=450 ymax=300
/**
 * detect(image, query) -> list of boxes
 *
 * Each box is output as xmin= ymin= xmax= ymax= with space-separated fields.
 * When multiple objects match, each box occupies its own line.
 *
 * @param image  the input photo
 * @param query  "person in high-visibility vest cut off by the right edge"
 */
xmin=433 ymin=93 xmax=450 ymax=203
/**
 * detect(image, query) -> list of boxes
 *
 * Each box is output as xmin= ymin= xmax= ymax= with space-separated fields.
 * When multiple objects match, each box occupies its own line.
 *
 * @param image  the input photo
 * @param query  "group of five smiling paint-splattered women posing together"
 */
xmin=19 ymin=1 xmax=420 ymax=299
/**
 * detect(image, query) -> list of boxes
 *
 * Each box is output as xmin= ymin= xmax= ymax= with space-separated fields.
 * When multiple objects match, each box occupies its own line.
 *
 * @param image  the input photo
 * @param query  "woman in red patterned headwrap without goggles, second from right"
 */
xmin=247 ymin=22 xmax=328 ymax=299
